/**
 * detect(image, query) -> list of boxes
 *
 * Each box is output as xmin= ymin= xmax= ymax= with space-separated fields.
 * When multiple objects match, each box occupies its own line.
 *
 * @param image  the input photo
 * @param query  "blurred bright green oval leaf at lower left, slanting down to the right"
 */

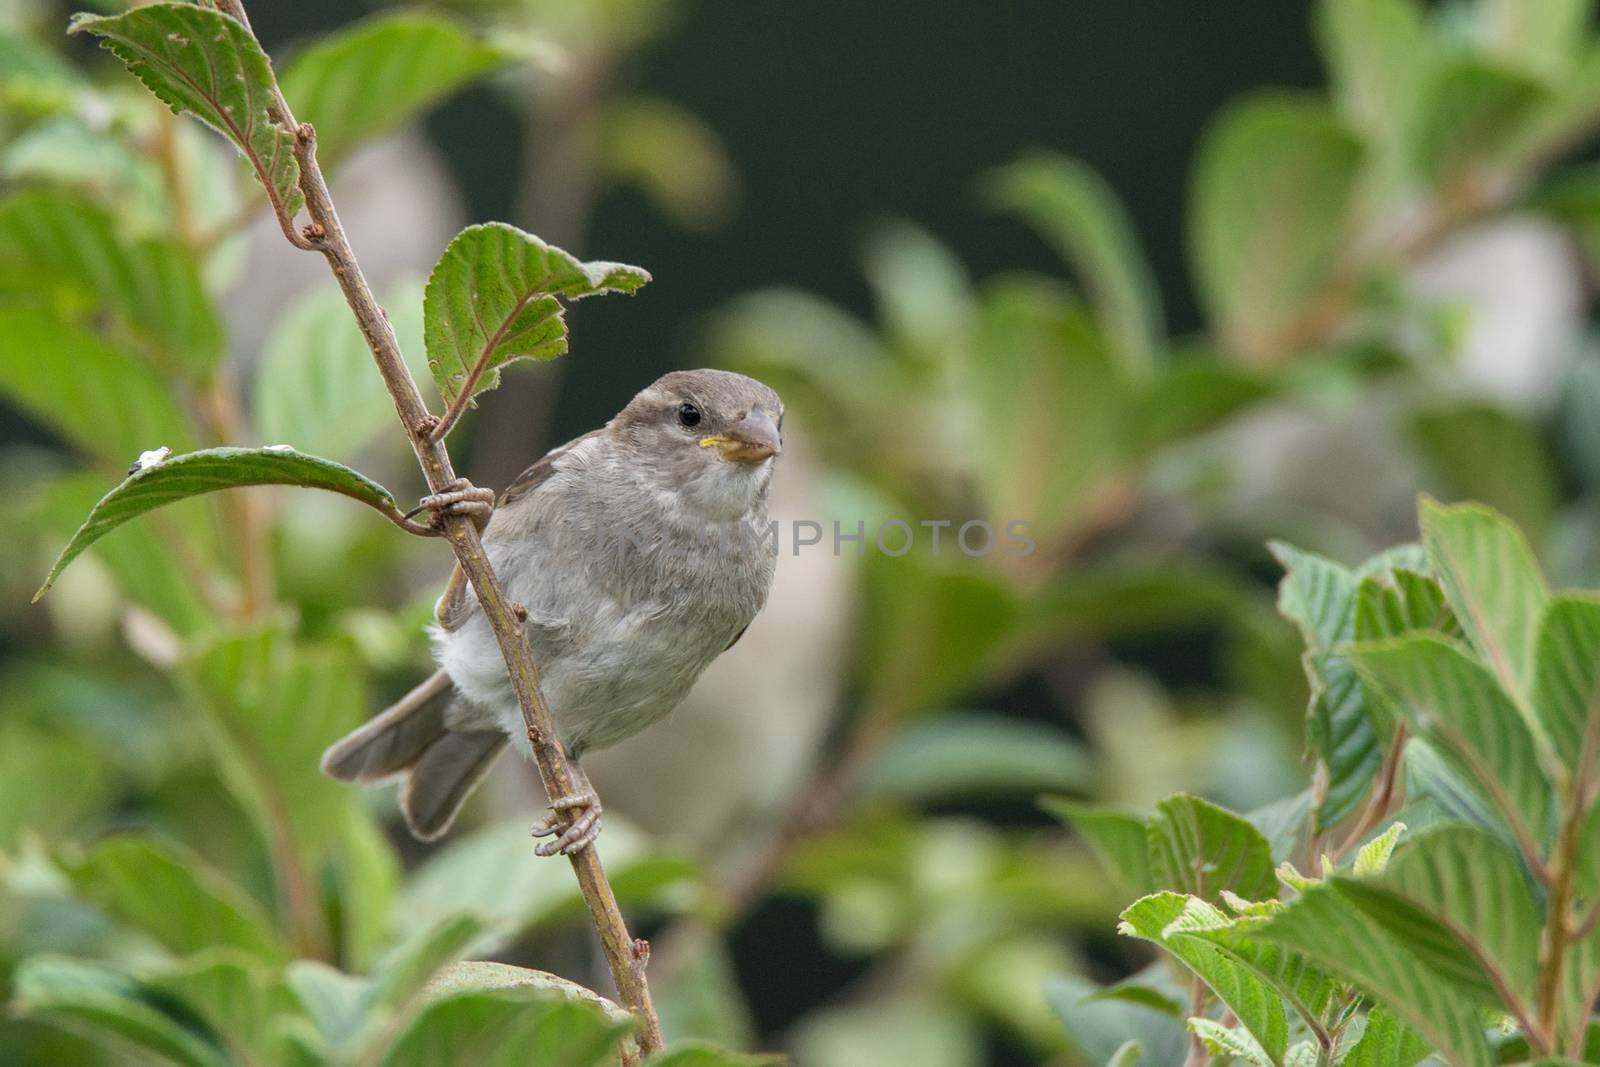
xmin=62 ymin=837 xmax=283 ymax=960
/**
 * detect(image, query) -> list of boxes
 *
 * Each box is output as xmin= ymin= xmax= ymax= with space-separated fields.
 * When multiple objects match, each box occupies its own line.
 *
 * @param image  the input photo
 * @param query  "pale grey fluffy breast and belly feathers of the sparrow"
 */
xmin=435 ymin=438 xmax=776 ymax=755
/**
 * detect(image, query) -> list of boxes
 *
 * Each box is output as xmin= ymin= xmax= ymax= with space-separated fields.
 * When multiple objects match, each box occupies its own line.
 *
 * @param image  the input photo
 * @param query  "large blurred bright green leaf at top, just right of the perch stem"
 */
xmin=280 ymin=13 xmax=510 ymax=170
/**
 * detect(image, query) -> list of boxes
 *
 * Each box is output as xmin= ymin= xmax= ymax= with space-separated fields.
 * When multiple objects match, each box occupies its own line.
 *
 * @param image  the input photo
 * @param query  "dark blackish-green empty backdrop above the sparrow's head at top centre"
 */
xmin=251 ymin=0 xmax=1322 ymax=442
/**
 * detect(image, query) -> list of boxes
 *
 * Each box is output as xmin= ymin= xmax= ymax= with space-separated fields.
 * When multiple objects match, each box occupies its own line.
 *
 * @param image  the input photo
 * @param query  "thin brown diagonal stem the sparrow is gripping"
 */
xmin=219 ymin=0 xmax=662 ymax=1054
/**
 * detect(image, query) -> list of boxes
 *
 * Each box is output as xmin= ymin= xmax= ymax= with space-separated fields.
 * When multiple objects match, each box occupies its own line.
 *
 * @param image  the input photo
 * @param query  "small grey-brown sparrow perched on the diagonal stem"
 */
xmin=322 ymin=370 xmax=784 ymax=856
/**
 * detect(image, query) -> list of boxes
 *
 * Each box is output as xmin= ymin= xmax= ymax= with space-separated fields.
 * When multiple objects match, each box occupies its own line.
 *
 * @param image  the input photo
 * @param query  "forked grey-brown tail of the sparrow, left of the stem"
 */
xmin=322 ymin=670 xmax=506 ymax=841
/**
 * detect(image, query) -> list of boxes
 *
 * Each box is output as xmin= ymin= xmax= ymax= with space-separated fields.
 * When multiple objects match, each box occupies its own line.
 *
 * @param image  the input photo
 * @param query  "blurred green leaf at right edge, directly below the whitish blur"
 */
xmin=1406 ymin=405 xmax=1558 ymax=541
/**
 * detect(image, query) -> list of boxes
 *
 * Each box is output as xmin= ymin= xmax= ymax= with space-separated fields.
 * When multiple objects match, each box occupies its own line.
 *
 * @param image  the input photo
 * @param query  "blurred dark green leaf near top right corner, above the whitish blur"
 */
xmin=1411 ymin=58 xmax=1549 ymax=189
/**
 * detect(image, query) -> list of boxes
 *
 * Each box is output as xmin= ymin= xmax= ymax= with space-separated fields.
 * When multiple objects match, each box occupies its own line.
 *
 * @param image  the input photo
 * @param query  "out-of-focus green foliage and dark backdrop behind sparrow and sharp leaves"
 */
xmin=0 ymin=0 xmax=1600 ymax=1067
